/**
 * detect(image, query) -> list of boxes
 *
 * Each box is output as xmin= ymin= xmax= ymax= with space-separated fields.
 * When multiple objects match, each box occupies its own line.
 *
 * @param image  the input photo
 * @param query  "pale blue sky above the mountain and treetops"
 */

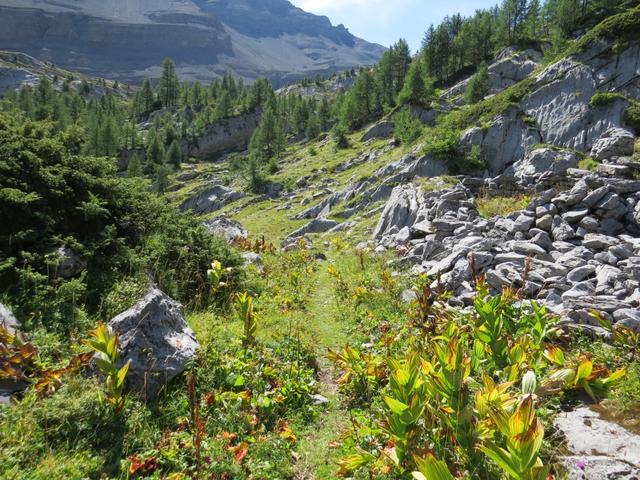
xmin=290 ymin=0 xmax=499 ymax=51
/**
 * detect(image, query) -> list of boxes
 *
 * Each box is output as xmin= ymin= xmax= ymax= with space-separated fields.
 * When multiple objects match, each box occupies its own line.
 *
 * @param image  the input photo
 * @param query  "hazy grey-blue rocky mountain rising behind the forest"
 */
xmin=0 ymin=0 xmax=384 ymax=84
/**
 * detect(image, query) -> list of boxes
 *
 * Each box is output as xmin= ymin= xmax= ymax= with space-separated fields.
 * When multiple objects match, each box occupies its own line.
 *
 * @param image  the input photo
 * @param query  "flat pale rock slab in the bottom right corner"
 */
xmin=555 ymin=407 xmax=640 ymax=480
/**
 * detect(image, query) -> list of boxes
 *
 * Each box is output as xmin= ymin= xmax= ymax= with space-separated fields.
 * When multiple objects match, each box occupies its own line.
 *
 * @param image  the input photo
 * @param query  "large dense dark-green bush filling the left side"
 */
xmin=0 ymin=114 xmax=242 ymax=333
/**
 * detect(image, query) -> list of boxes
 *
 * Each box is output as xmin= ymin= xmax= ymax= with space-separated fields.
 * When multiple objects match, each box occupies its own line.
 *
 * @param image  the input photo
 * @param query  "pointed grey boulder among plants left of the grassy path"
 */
xmin=109 ymin=288 xmax=199 ymax=400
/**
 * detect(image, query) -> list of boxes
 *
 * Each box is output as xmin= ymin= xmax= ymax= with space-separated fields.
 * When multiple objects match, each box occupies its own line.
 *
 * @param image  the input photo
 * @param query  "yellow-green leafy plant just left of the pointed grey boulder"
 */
xmin=85 ymin=322 xmax=131 ymax=413
